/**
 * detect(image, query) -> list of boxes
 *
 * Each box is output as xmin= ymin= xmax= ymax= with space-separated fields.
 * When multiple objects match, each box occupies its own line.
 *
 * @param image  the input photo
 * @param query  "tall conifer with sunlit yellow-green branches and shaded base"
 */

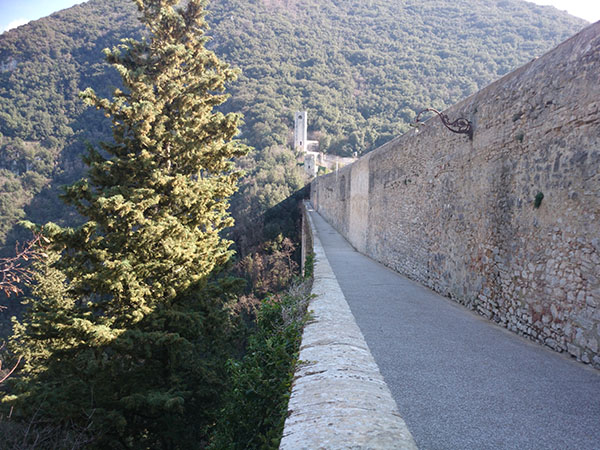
xmin=5 ymin=0 xmax=245 ymax=448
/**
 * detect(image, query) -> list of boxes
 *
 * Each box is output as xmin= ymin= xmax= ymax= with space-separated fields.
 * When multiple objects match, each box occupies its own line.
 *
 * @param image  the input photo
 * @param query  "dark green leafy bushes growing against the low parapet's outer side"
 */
xmin=210 ymin=285 xmax=309 ymax=450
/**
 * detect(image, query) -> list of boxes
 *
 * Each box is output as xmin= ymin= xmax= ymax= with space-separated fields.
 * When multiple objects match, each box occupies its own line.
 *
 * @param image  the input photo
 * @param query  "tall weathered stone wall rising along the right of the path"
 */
xmin=311 ymin=22 xmax=600 ymax=368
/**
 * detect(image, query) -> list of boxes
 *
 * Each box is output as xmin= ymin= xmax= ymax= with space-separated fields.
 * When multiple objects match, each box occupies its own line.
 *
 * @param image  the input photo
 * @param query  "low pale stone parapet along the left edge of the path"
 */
xmin=279 ymin=204 xmax=417 ymax=450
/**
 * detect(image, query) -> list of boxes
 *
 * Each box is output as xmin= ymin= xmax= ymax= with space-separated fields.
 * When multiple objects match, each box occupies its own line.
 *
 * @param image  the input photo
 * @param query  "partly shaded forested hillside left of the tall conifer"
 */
xmin=0 ymin=0 xmax=140 ymax=246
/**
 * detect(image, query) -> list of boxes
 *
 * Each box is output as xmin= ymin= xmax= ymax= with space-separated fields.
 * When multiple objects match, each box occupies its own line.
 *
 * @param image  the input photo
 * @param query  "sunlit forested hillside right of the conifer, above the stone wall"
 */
xmin=211 ymin=0 xmax=583 ymax=156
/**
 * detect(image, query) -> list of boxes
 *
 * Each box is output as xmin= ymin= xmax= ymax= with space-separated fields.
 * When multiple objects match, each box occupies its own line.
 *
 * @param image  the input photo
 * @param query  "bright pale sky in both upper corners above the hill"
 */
xmin=0 ymin=0 xmax=600 ymax=33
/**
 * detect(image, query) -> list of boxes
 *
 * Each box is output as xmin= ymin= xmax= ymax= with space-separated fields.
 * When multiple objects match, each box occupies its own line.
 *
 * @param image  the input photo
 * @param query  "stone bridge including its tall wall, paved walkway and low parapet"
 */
xmin=281 ymin=22 xmax=600 ymax=449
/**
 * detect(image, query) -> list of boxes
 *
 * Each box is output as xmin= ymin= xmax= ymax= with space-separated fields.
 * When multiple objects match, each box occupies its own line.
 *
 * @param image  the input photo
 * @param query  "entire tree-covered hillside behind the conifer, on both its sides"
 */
xmin=0 ymin=0 xmax=586 ymax=251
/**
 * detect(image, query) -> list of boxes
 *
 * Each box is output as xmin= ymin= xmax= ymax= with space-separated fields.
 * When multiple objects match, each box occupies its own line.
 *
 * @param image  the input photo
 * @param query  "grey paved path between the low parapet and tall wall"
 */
xmin=311 ymin=213 xmax=600 ymax=450
